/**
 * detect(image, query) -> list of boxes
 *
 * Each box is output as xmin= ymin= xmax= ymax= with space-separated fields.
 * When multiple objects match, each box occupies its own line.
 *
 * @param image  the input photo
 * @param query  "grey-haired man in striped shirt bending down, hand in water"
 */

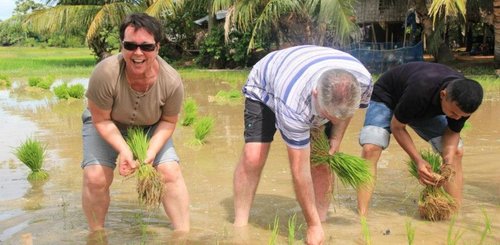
xmin=233 ymin=45 xmax=372 ymax=244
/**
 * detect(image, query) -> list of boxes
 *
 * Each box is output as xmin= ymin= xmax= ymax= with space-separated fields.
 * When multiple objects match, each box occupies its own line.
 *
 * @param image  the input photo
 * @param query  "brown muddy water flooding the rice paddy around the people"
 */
xmin=0 ymin=80 xmax=500 ymax=244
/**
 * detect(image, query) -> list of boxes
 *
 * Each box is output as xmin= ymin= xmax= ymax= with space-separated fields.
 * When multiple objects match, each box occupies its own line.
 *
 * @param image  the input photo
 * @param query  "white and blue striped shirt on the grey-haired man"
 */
xmin=243 ymin=45 xmax=373 ymax=148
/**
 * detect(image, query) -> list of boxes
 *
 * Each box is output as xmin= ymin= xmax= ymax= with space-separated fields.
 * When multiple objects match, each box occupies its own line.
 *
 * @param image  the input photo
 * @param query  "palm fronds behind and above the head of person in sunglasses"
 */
xmin=25 ymin=0 xmax=183 ymax=59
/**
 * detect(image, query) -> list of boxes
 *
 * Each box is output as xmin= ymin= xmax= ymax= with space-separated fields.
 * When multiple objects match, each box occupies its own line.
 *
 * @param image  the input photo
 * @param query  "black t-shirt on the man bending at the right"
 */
xmin=371 ymin=62 xmax=468 ymax=132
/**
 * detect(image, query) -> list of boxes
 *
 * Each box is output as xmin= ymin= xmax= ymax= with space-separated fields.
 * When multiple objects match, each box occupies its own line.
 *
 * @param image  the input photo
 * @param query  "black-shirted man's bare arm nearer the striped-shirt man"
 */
xmin=391 ymin=116 xmax=435 ymax=185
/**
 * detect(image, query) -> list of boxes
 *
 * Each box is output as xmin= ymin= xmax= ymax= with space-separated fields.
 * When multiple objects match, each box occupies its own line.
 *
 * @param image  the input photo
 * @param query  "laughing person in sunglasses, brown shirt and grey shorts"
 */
xmin=81 ymin=14 xmax=189 ymax=232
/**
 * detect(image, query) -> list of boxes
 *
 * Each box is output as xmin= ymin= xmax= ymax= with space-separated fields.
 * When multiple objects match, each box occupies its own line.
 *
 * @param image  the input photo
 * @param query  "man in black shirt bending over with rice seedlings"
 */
xmin=358 ymin=62 xmax=483 ymax=216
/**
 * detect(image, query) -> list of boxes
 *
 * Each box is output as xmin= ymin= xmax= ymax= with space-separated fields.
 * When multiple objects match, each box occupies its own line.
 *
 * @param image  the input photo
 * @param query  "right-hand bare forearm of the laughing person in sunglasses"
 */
xmin=145 ymin=115 xmax=179 ymax=163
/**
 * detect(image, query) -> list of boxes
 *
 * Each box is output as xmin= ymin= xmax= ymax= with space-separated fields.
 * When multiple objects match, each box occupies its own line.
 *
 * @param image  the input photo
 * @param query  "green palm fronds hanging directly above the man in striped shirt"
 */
xmin=213 ymin=0 xmax=357 ymax=51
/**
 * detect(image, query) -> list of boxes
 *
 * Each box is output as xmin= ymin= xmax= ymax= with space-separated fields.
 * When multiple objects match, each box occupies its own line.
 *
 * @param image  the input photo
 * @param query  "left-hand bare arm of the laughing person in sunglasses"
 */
xmin=88 ymin=100 xmax=136 ymax=175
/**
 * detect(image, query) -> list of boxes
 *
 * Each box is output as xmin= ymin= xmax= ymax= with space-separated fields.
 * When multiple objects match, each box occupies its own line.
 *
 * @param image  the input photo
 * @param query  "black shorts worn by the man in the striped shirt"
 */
xmin=244 ymin=99 xmax=333 ymax=143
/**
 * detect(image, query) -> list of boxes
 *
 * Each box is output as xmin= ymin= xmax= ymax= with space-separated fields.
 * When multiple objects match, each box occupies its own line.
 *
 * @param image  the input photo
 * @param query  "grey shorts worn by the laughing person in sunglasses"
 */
xmin=81 ymin=109 xmax=179 ymax=169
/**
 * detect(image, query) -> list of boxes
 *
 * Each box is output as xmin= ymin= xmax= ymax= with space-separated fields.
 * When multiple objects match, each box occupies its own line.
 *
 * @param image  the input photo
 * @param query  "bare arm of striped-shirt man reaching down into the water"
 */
xmin=287 ymin=147 xmax=324 ymax=244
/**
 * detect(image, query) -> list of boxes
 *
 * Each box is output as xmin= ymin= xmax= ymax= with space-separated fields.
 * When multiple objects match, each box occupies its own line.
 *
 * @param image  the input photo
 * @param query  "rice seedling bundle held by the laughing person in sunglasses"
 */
xmin=126 ymin=127 xmax=163 ymax=208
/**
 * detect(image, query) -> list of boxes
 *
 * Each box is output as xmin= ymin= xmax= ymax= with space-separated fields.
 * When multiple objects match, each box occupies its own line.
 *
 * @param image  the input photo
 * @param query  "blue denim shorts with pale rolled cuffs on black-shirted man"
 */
xmin=359 ymin=101 xmax=463 ymax=152
